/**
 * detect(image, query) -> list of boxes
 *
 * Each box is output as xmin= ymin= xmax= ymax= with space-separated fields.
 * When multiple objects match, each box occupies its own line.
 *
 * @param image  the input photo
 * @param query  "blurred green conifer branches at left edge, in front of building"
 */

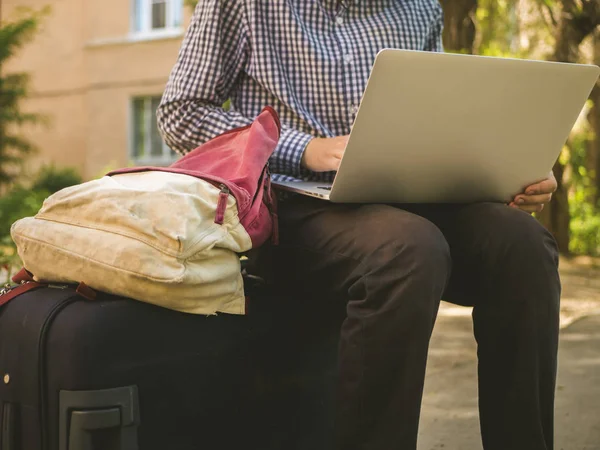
xmin=0 ymin=11 xmax=45 ymax=192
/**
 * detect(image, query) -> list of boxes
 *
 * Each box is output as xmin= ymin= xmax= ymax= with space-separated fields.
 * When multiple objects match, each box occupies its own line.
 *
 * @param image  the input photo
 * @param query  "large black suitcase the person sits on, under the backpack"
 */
xmin=0 ymin=286 xmax=344 ymax=450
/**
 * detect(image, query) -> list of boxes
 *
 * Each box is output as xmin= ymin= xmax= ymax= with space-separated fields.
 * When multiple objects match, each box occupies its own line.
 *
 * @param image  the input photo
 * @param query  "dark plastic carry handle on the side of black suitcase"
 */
xmin=59 ymin=386 xmax=140 ymax=450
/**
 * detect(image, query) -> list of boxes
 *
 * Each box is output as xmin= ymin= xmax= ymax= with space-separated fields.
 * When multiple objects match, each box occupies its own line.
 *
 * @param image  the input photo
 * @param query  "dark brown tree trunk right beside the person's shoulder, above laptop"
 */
xmin=440 ymin=0 xmax=477 ymax=53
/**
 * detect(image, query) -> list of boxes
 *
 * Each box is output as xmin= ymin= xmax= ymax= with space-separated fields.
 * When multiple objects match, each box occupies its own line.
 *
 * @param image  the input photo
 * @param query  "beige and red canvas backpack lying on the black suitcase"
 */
xmin=11 ymin=107 xmax=281 ymax=315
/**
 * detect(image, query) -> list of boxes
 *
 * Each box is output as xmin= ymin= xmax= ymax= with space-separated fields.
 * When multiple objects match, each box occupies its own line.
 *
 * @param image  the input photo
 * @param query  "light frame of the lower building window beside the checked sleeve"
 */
xmin=128 ymin=94 xmax=180 ymax=166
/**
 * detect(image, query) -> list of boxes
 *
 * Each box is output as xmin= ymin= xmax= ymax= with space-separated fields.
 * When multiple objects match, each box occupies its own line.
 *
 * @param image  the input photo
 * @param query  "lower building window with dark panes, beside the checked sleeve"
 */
xmin=131 ymin=96 xmax=178 ymax=165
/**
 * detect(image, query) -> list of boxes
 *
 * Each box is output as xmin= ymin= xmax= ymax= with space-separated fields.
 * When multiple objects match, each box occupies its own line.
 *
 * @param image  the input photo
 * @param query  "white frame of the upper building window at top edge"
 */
xmin=131 ymin=0 xmax=184 ymax=39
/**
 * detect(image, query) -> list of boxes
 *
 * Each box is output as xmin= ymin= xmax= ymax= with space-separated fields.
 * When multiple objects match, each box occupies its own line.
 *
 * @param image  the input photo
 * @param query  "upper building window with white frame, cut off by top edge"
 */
xmin=133 ymin=0 xmax=183 ymax=35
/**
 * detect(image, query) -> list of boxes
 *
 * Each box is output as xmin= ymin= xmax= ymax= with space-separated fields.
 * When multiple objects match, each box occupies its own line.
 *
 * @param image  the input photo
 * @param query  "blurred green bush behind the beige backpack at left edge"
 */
xmin=0 ymin=166 xmax=82 ymax=281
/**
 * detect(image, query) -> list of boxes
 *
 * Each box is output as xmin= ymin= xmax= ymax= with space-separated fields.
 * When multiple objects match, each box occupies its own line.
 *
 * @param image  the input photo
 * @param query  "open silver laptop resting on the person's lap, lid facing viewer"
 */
xmin=274 ymin=49 xmax=600 ymax=203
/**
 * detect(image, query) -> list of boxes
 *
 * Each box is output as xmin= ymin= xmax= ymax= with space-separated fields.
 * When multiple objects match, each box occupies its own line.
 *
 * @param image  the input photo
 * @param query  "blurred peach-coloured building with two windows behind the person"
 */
xmin=0 ymin=0 xmax=191 ymax=179
